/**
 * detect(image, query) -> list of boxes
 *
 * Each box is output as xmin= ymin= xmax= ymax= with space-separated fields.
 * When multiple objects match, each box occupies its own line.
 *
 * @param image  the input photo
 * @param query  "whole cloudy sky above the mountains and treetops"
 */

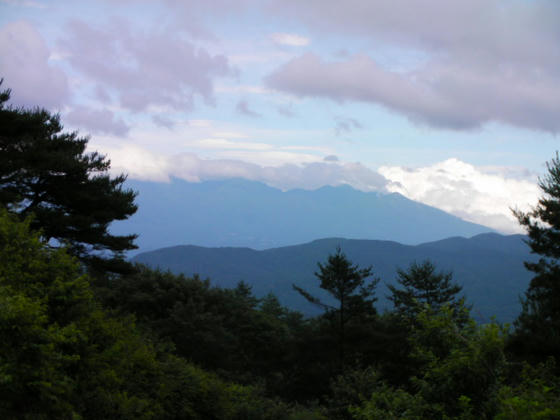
xmin=0 ymin=0 xmax=560 ymax=233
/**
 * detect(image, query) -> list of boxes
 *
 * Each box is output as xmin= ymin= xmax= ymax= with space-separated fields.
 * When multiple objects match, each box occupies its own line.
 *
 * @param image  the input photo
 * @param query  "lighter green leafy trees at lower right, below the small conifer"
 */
xmin=354 ymin=306 xmax=507 ymax=420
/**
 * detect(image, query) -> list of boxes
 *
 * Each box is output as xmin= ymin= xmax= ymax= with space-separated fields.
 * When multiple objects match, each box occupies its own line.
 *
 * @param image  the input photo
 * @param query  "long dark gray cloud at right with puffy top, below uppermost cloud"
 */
xmin=267 ymin=53 xmax=560 ymax=132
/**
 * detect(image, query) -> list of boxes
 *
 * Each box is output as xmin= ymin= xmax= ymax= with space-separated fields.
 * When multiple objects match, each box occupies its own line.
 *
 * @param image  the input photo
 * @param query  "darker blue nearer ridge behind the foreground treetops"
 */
xmin=134 ymin=233 xmax=536 ymax=322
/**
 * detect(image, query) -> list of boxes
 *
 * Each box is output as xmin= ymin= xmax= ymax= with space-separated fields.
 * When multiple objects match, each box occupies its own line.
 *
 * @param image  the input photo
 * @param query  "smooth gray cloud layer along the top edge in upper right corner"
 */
xmin=268 ymin=0 xmax=560 ymax=69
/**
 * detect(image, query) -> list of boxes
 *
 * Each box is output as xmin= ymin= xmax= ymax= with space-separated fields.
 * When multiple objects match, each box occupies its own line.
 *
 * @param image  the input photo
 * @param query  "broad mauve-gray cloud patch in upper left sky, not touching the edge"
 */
xmin=60 ymin=20 xmax=232 ymax=111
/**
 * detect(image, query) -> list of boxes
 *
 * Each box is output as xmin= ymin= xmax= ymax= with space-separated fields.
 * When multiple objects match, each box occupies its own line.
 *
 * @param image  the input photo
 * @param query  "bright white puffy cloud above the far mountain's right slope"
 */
xmin=379 ymin=159 xmax=540 ymax=233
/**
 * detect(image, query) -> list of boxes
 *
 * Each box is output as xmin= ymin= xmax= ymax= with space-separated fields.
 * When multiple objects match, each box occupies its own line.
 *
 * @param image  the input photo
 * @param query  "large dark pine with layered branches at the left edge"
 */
xmin=0 ymin=83 xmax=136 ymax=272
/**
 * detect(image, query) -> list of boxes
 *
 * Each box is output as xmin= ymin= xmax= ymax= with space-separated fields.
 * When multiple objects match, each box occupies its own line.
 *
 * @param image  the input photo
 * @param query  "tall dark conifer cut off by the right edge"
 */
xmin=511 ymin=154 xmax=560 ymax=361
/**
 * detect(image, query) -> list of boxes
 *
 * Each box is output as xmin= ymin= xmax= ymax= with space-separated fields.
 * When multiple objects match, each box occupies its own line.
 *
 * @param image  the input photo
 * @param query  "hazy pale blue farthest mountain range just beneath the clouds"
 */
xmin=112 ymin=179 xmax=492 ymax=251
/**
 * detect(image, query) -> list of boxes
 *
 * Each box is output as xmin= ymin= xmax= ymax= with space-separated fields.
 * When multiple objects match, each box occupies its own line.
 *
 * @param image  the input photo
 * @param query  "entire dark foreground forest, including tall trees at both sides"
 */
xmin=0 ymin=83 xmax=560 ymax=420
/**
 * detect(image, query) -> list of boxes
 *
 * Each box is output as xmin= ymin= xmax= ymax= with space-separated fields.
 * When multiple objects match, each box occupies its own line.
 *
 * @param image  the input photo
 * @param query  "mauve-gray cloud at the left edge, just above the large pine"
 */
xmin=0 ymin=21 xmax=70 ymax=109
